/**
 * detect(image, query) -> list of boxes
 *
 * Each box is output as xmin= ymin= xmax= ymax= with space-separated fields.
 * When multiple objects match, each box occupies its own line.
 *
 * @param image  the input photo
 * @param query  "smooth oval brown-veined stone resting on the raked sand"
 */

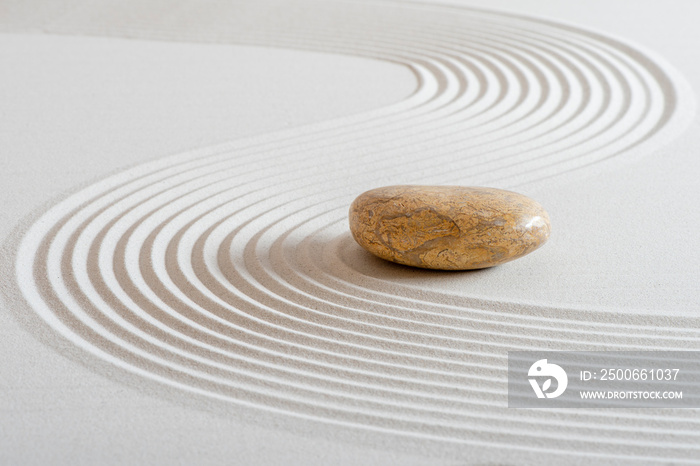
xmin=350 ymin=186 xmax=550 ymax=270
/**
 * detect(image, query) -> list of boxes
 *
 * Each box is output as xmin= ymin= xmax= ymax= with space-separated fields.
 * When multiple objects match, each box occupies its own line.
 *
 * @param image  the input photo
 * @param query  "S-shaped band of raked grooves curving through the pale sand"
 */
xmin=8 ymin=1 xmax=700 ymax=460
